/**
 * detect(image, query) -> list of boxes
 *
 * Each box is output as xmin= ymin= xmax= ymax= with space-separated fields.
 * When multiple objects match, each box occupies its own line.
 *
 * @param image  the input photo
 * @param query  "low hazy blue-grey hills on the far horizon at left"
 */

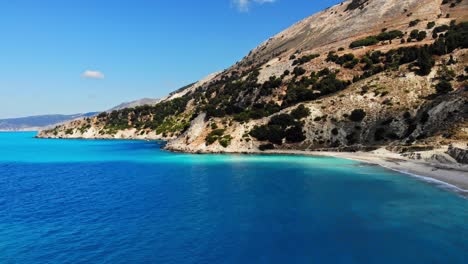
xmin=0 ymin=112 xmax=99 ymax=131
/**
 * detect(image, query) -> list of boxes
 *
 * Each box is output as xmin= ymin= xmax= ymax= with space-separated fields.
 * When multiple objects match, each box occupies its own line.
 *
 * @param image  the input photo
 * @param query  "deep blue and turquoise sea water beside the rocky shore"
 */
xmin=0 ymin=133 xmax=468 ymax=264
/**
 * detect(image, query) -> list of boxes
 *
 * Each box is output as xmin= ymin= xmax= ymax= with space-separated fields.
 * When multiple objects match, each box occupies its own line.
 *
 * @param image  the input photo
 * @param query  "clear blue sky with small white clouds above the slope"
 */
xmin=0 ymin=0 xmax=341 ymax=118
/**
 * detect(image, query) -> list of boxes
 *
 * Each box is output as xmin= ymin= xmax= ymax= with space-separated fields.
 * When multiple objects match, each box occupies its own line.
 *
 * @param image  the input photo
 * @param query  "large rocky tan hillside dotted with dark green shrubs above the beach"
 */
xmin=39 ymin=0 xmax=468 ymax=163
